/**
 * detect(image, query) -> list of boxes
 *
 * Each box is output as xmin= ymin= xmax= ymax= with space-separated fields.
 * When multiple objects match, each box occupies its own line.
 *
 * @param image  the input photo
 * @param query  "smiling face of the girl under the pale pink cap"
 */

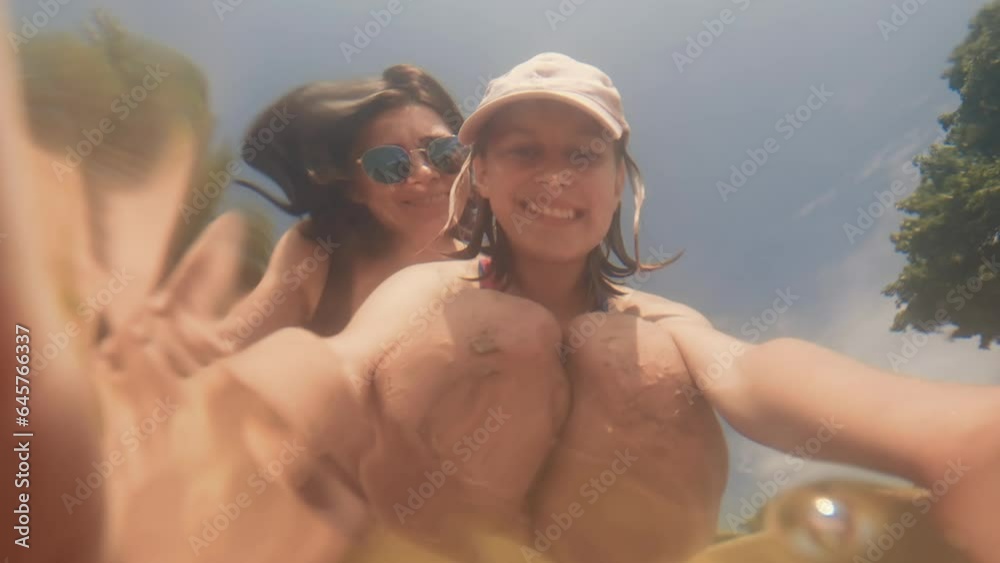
xmin=473 ymin=100 xmax=625 ymax=262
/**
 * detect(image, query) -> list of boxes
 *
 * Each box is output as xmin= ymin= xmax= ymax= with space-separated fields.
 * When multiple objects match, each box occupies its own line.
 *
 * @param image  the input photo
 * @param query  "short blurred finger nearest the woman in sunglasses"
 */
xmin=154 ymin=212 xmax=247 ymax=318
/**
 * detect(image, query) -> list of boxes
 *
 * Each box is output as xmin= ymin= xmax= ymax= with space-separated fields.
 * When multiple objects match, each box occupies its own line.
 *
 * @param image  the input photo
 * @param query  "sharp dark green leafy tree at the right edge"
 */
xmin=884 ymin=1 xmax=1000 ymax=348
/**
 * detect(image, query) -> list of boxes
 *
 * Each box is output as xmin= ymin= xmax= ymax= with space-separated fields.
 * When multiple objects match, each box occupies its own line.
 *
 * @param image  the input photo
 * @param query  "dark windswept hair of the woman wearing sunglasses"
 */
xmin=235 ymin=64 xmax=462 ymax=254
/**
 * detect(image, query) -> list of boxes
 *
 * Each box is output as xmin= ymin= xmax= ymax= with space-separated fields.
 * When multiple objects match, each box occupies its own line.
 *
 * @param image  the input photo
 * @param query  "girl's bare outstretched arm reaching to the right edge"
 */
xmin=660 ymin=312 xmax=1000 ymax=562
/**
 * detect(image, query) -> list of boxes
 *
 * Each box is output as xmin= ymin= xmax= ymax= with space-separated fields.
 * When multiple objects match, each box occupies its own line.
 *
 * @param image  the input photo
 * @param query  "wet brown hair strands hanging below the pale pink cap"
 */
xmin=448 ymin=124 xmax=684 ymax=299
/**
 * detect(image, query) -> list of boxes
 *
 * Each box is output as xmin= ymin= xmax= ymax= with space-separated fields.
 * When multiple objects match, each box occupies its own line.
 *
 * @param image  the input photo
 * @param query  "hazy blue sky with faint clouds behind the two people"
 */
xmin=12 ymin=0 xmax=1000 ymax=532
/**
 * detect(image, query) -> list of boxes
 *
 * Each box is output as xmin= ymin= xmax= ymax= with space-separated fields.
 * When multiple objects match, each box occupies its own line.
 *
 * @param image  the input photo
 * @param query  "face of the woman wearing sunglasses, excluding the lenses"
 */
xmin=352 ymin=104 xmax=455 ymax=246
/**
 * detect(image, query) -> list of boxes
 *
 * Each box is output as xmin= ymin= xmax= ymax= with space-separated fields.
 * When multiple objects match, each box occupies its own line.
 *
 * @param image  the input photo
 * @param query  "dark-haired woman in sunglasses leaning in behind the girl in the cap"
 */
xmin=109 ymin=65 xmax=472 ymax=376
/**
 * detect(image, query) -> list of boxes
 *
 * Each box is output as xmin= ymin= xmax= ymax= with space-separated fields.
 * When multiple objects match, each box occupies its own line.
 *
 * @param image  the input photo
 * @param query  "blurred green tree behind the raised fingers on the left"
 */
xmin=19 ymin=11 xmax=272 ymax=294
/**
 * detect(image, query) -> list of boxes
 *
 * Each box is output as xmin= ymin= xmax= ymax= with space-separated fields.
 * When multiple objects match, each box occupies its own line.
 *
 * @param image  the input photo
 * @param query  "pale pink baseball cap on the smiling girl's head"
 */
xmin=458 ymin=53 xmax=629 ymax=145
